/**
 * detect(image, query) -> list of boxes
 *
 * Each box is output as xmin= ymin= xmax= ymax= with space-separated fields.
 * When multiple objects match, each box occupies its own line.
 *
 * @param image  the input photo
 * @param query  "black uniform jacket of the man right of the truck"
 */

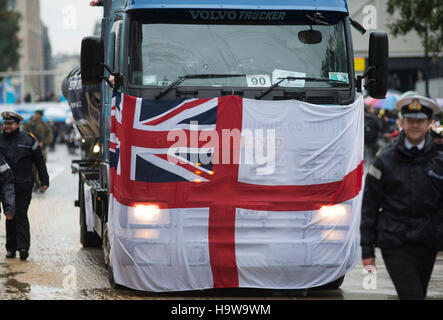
xmin=360 ymin=132 xmax=443 ymax=258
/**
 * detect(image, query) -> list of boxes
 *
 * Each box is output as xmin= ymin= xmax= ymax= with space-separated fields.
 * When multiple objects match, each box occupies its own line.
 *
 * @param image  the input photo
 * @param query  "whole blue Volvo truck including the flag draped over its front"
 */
xmin=63 ymin=0 xmax=388 ymax=292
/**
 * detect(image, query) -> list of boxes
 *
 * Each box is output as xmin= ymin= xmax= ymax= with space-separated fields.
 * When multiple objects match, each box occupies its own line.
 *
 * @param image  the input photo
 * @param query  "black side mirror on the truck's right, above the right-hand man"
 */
xmin=365 ymin=31 xmax=389 ymax=99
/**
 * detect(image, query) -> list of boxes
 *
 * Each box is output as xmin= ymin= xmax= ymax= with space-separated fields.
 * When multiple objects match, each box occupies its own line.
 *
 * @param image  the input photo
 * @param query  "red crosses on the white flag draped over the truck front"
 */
xmin=110 ymin=92 xmax=363 ymax=288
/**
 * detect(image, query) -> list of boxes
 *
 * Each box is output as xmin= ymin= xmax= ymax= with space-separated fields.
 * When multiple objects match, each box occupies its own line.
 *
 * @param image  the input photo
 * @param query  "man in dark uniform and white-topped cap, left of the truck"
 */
xmin=0 ymin=111 xmax=49 ymax=260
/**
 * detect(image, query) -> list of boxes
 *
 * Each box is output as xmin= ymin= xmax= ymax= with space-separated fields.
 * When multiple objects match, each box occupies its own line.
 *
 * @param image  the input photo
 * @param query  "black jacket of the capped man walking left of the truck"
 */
xmin=0 ymin=129 xmax=49 ymax=193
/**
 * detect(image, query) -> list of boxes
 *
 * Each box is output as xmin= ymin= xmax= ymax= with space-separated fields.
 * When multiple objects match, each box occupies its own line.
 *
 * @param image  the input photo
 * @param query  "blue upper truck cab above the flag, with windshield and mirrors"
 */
xmin=81 ymin=0 xmax=388 ymax=164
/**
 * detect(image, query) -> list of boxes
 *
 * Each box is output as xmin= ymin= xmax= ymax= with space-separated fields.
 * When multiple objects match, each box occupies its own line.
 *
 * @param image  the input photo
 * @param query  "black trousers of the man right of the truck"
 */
xmin=381 ymin=245 xmax=437 ymax=300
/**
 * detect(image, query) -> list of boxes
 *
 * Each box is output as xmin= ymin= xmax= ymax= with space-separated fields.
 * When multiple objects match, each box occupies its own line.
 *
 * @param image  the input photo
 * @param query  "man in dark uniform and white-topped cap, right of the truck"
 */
xmin=360 ymin=95 xmax=443 ymax=299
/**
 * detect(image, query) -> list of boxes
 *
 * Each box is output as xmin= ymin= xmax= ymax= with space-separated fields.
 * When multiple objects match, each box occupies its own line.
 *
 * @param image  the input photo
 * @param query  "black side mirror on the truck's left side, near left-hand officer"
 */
xmin=80 ymin=37 xmax=105 ymax=85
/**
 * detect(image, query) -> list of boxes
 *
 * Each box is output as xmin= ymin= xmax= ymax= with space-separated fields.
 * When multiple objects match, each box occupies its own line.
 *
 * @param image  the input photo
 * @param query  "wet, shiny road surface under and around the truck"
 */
xmin=0 ymin=145 xmax=443 ymax=300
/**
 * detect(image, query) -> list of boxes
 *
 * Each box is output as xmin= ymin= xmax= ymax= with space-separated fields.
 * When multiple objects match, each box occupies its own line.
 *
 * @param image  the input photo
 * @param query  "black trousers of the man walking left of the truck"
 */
xmin=6 ymin=189 xmax=32 ymax=251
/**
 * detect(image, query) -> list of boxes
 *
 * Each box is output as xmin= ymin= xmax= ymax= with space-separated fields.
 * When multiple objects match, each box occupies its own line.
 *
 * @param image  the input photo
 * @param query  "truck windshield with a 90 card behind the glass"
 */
xmin=129 ymin=20 xmax=350 ymax=88
